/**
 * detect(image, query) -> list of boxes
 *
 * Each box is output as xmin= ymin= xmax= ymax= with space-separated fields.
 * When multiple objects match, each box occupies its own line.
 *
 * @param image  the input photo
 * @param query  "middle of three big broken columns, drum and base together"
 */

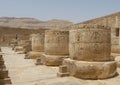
xmin=41 ymin=30 xmax=69 ymax=66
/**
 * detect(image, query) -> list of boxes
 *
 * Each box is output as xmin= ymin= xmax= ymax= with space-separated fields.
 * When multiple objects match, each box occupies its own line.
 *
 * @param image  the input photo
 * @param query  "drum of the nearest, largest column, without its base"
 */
xmin=69 ymin=26 xmax=111 ymax=61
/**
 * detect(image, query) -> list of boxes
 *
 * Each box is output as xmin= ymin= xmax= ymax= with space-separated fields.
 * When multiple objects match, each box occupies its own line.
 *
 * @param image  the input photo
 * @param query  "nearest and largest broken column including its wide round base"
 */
xmin=58 ymin=25 xmax=116 ymax=79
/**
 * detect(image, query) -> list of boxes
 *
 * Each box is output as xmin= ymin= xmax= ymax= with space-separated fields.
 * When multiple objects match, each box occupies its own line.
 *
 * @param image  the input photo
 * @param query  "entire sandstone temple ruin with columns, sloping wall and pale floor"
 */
xmin=0 ymin=13 xmax=120 ymax=85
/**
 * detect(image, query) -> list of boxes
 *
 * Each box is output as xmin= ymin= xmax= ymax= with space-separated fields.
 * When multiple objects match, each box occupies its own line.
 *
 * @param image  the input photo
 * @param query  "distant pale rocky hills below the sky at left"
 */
xmin=0 ymin=17 xmax=73 ymax=29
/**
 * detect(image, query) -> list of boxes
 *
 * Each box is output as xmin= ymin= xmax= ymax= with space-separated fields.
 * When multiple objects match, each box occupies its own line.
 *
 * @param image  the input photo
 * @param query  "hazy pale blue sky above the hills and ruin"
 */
xmin=0 ymin=0 xmax=120 ymax=23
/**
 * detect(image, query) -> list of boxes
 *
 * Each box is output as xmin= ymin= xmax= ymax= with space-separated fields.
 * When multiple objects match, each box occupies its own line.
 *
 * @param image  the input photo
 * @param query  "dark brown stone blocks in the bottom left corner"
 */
xmin=0 ymin=55 xmax=11 ymax=85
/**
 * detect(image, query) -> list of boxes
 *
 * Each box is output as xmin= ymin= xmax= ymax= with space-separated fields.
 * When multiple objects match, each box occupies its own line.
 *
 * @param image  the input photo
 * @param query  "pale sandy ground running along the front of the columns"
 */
xmin=2 ymin=47 xmax=120 ymax=85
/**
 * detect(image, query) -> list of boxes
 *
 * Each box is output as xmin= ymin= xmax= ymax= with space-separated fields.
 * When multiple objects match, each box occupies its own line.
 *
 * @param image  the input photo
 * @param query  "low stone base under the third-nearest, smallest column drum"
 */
xmin=25 ymin=51 xmax=44 ymax=59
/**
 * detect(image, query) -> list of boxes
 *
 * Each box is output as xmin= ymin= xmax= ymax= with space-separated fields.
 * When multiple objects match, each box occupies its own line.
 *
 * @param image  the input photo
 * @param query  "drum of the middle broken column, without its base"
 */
xmin=45 ymin=30 xmax=69 ymax=55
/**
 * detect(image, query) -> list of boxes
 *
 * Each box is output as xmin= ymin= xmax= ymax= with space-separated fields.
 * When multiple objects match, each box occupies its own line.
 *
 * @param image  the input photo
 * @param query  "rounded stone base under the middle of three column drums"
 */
xmin=41 ymin=54 xmax=68 ymax=66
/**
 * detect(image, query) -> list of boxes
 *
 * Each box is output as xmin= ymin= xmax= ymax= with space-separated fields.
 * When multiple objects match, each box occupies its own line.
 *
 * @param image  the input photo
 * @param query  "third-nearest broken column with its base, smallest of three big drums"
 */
xmin=25 ymin=33 xmax=44 ymax=59
